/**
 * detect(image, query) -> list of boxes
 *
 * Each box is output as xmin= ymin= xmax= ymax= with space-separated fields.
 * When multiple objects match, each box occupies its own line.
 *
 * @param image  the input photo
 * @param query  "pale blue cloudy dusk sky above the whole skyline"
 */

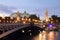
xmin=0 ymin=0 xmax=60 ymax=19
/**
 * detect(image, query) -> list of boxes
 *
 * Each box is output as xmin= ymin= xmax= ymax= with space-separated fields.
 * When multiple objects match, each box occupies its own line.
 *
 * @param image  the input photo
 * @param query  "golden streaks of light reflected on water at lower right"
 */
xmin=33 ymin=31 xmax=60 ymax=40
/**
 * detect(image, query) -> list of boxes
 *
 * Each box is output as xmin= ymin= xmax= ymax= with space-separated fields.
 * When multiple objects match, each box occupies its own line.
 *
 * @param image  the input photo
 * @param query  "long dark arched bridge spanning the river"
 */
xmin=0 ymin=23 xmax=42 ymax=38
